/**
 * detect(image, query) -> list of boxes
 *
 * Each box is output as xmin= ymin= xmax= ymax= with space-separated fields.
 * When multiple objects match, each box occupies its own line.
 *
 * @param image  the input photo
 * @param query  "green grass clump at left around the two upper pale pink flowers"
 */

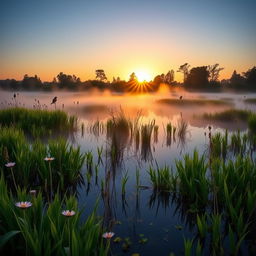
xmin=0 ymin=128 xmax=85 ymax=193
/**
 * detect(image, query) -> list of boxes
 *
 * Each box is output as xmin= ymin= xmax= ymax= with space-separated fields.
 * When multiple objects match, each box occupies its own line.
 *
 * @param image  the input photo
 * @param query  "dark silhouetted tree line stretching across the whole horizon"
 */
xmin=0 ymin=63 xmax=256 ymax=92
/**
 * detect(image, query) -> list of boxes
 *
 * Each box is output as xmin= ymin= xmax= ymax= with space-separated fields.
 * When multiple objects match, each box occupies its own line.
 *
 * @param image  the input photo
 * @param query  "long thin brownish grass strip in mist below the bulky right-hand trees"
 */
xmin=156 ymin=99 xmax=233 ymax=107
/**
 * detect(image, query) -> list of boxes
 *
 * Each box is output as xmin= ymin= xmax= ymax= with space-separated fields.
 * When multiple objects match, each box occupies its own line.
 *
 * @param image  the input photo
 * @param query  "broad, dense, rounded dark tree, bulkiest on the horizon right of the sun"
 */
xmin=185 ymin=66 xmax=209 ymax=87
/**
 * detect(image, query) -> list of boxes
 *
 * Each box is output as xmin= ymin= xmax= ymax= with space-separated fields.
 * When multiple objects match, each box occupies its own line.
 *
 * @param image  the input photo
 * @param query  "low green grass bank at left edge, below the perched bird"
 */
xmin=0 ymin=108 xmax=77 ymax=137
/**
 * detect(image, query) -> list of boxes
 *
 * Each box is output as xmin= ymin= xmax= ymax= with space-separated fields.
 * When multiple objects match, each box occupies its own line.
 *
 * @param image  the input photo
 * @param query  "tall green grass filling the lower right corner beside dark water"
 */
xmin=149 ymin=151 xmax=256 ymax=255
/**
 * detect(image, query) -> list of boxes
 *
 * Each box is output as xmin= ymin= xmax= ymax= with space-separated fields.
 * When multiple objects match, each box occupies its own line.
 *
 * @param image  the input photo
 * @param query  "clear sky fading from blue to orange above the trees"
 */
xmin=0 ymin=0 xmax=256 ymax=81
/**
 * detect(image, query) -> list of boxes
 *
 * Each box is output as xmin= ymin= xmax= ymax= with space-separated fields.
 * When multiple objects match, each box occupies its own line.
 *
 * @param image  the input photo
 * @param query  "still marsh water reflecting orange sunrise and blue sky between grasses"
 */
xmin=0 ymin=90 xmax=256 ymax=256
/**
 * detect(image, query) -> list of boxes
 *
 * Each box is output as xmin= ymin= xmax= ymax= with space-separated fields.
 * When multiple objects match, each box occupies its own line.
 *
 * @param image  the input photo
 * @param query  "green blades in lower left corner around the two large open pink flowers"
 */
xmin=0 ymin=175 xmax=109 ymax=256
